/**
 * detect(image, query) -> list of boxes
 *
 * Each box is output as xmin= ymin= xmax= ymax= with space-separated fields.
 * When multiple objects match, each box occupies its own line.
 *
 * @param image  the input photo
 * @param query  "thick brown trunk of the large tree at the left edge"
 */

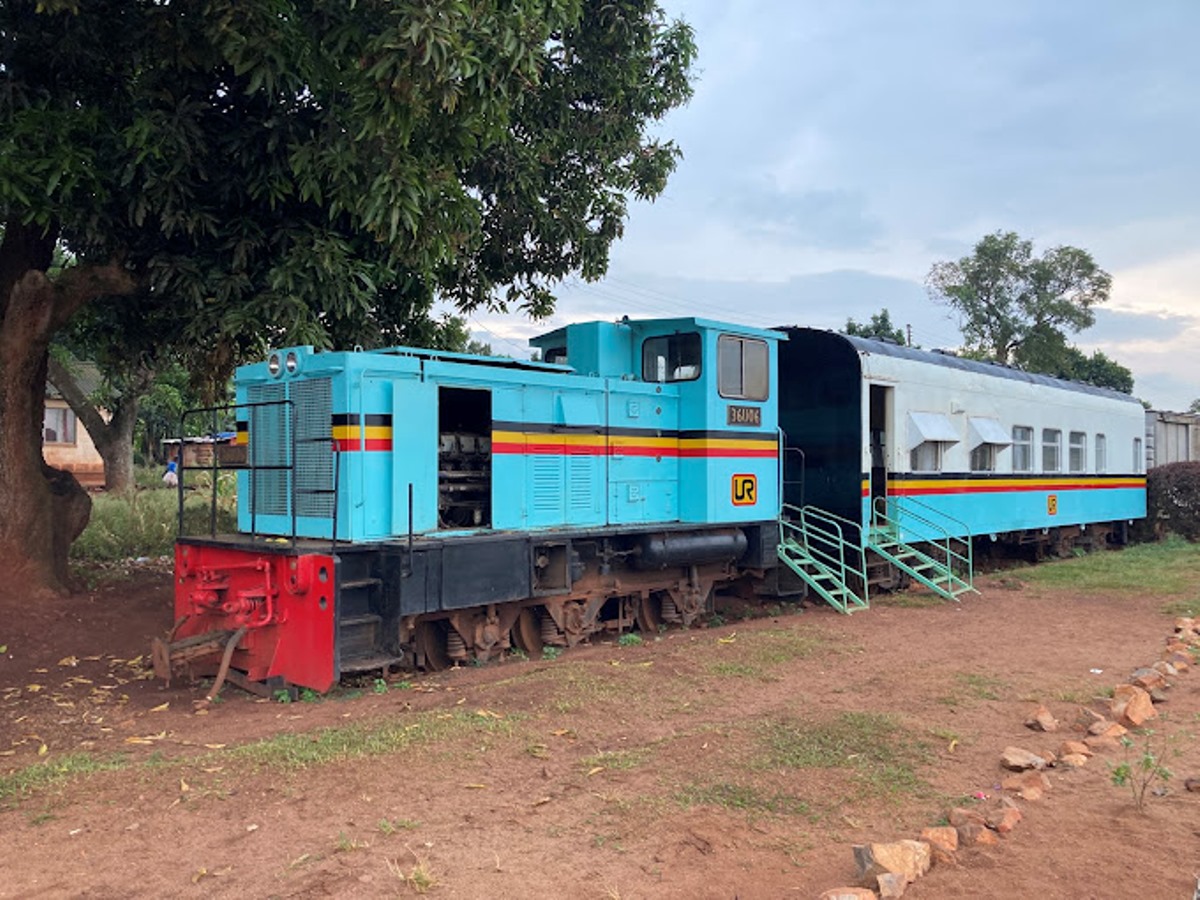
xmin=0 ymin=221 xmax=132 ymax=590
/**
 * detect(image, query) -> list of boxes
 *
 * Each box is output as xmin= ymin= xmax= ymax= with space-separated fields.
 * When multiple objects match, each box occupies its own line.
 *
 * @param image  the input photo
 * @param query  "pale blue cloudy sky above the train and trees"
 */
xmin=472 ymin=0 xmax=1200 ymax=409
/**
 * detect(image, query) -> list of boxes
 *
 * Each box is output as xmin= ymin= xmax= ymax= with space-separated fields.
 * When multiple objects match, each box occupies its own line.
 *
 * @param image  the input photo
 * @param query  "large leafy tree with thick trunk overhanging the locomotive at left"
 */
xmin=0 ymin=0 xmax=695 ymax=587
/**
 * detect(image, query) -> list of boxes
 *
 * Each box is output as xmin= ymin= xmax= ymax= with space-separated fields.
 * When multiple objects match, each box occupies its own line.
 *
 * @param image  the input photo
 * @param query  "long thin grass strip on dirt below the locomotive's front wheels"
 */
xmin=229 ymin=710 xmax=512 ymax=769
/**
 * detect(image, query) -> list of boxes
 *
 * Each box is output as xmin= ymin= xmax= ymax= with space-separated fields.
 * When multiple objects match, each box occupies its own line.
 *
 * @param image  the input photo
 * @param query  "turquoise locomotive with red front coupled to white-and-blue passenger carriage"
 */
xmin=154 ymin=318 xmax=1145 ymax=691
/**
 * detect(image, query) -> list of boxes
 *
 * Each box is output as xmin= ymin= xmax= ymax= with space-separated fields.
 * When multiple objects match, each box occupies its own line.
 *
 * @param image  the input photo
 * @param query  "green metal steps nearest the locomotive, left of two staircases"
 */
xmin=776 ymin=504 xmax=869 ymax=613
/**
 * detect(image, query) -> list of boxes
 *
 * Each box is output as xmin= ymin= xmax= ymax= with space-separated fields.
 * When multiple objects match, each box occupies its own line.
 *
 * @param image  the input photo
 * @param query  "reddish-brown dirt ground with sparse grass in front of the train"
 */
xmin=0 ymin=566 xmax=1200 ymax=900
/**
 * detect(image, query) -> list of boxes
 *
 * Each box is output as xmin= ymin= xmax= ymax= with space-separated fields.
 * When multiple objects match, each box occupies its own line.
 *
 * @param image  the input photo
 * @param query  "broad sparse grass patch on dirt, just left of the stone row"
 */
xmin=763 ymin=712 xmax=928 ymax=798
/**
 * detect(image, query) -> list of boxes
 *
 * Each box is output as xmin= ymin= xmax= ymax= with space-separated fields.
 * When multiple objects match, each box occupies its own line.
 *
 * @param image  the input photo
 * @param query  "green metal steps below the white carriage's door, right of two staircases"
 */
xmin=866 ymin=497 xmax=978 ymax=601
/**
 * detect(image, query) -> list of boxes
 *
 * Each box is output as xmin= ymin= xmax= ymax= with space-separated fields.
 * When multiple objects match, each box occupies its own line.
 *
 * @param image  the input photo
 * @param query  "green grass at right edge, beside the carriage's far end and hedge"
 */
xmin=1018 ymin=535 xmax=1200 ymax=605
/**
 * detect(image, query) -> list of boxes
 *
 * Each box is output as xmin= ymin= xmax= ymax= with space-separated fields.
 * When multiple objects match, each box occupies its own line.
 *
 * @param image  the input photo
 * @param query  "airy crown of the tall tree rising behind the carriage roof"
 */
xmin=925 ymin=232 xmax=1112 ymax=364
